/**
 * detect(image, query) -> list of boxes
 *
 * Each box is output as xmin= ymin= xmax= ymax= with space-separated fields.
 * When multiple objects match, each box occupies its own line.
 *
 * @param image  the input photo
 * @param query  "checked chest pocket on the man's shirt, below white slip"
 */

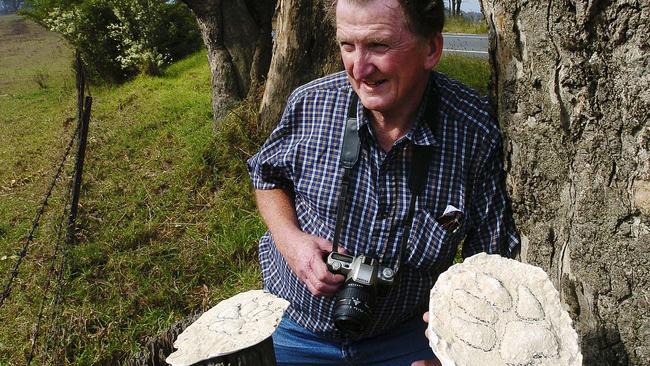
xmin=406 ymin=210 xmax=463 ymax=271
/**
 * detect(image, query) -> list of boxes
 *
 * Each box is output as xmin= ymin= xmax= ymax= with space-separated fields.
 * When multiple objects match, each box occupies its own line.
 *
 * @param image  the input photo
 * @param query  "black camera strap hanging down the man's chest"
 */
xmin=332 ymin=91 xmax=437 ymax=273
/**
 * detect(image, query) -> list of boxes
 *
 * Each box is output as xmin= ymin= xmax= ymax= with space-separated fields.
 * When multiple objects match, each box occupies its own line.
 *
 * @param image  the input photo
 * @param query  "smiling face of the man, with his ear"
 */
xmin=336 ymin=0 xmax=442 ymax=118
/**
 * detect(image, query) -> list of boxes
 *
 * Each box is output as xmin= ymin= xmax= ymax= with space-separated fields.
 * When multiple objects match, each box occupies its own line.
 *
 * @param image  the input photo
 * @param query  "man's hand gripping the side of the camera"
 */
xmin=276 ymin=231 xmax=345 ymax=297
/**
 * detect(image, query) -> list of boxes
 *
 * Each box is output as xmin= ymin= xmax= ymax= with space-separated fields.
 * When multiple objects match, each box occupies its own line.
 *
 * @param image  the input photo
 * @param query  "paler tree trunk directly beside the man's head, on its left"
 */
xmin=259 ymin=0 xmax=341 ymax=132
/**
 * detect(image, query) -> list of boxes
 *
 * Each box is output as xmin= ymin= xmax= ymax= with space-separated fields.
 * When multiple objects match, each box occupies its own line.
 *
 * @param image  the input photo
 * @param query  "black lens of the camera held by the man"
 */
xmin=334 ymin=281 xmax=375 ymax=335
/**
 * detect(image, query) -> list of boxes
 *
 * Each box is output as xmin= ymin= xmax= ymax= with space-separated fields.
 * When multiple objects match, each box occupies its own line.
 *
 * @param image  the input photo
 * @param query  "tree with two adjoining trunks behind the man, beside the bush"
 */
xmin=183 ymin=0 xmax=340 ymax=131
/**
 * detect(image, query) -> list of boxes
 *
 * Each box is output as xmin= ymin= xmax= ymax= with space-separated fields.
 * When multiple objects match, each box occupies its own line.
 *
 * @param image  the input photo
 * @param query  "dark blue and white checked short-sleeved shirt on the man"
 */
xmin=248 ymin=72 xmax=519 ymax=339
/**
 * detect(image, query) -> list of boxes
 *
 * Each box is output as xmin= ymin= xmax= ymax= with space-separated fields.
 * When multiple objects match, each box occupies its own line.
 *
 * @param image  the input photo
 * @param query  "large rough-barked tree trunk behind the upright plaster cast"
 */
xmin=482 ymin=0 xmax=650 ymax=365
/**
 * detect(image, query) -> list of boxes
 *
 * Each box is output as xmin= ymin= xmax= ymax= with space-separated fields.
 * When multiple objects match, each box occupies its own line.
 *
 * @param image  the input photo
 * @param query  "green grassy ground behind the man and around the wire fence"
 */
xmin=0 ymin=16 xmax=488 ymax=365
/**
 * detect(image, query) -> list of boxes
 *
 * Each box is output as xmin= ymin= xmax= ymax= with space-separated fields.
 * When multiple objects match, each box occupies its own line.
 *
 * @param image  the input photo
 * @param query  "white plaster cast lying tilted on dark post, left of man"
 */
xmin=166 ymin=290 xmax=289 ymax=366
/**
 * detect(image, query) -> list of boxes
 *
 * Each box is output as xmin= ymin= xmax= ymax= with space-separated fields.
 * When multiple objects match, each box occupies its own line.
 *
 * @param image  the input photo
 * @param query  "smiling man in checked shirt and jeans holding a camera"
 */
xmin=248 ymin=0 xmax=519 ymax=366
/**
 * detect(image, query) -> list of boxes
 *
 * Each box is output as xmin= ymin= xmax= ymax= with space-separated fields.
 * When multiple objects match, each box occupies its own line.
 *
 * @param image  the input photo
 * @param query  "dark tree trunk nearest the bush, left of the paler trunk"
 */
xmin=183 ymin=0 xmax=275 ymax=128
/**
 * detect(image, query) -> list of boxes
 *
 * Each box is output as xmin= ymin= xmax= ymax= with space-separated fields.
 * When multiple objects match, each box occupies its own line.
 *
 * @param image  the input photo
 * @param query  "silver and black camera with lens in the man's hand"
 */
xmin=327 ymin=252 xmax=395 ymax=335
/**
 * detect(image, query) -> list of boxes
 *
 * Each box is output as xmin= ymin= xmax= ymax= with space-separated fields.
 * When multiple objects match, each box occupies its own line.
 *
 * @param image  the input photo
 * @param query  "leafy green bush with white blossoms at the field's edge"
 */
xmin=28 ymin=0 xmax=201 ymax=82
